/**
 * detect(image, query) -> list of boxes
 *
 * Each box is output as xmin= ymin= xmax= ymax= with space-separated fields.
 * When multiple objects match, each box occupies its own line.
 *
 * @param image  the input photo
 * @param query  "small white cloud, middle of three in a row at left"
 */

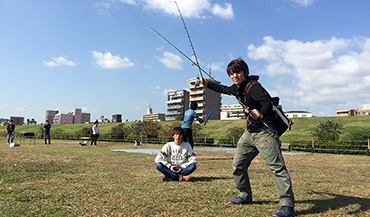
xmin=92 ymin=51 xmax=135 ymax=69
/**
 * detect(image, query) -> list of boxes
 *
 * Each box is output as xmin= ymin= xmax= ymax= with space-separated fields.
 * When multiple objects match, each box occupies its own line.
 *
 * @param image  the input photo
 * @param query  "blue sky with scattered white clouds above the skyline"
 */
xmin=0 ymin=0 xmax=370 ymax=123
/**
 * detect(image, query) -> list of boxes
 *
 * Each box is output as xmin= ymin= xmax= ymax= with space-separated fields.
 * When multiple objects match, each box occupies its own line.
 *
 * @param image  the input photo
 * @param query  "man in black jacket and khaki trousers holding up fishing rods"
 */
xmin=203 ymin=58 xmax=295 ymax=217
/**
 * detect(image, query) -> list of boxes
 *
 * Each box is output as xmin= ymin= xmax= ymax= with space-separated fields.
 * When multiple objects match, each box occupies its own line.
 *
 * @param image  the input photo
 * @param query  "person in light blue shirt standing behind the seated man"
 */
xmin=181 ymin=102 xmax=207 ymax=148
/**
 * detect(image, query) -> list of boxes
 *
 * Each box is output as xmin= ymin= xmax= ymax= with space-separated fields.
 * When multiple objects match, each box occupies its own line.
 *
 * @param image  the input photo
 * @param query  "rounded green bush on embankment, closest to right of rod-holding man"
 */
xmin=312 ymin=120 xmax=342 ymax=140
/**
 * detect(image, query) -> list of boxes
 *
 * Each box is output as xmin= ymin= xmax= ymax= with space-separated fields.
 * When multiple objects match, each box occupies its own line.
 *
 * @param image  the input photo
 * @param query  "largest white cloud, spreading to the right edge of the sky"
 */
xmin=248 ymin=37 xmax=370 ymax=115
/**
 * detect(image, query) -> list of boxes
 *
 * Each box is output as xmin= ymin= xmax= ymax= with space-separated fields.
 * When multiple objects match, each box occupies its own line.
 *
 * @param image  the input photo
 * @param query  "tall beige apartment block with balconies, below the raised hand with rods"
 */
xmin=189 ymin=81 xmax=221 ymax=120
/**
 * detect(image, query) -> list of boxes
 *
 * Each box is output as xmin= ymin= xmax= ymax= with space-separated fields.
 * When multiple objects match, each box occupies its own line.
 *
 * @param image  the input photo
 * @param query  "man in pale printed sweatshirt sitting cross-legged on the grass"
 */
xmin=155 ymin=127 xmax=197 ymax=181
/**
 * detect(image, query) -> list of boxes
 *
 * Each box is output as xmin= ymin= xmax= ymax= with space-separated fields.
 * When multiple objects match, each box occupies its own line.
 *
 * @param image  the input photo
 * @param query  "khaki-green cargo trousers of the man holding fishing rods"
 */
xmin=233 ymin=130 xmax=294 ymax=207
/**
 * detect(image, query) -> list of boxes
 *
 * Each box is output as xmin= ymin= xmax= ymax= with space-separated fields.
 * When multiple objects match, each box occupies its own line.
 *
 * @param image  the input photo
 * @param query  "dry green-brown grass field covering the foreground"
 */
xmin=0 ymin=138 xmax=370 ymax=216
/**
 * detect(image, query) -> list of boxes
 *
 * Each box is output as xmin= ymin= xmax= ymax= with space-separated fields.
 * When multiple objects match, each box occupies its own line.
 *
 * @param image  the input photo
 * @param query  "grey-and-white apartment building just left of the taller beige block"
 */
xmin=166 ymin=90 xmax=189 ymax=121
